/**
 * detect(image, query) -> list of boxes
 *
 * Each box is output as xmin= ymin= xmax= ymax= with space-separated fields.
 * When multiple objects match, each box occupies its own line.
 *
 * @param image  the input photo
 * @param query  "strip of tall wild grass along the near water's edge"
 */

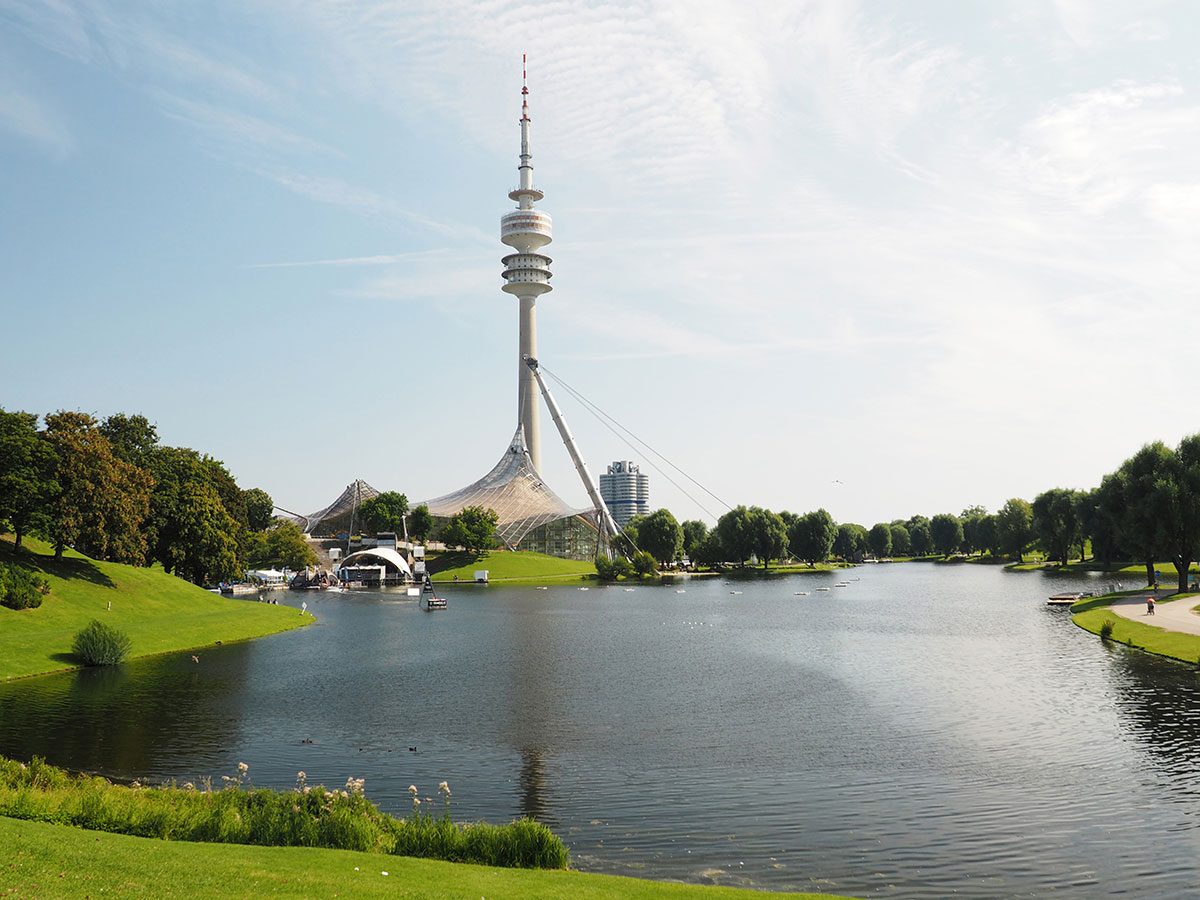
xmin=0 ymin=757 xmax=569 ymax=869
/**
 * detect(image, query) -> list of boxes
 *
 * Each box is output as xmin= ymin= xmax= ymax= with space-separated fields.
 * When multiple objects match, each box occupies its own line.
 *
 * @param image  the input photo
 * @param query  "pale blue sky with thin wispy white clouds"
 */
xmin=0 ymin=0 xmax=1200 ymax=527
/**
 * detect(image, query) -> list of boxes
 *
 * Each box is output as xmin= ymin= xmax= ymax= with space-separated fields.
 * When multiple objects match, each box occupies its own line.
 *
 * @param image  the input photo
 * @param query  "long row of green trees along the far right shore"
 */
xmin=609 ymin=434 xmax=1200 ymax=590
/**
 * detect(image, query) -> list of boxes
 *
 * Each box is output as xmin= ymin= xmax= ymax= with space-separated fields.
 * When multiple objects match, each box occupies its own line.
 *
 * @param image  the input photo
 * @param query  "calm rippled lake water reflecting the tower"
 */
xmin=0 ymin=564 xmax=1200 ymax=900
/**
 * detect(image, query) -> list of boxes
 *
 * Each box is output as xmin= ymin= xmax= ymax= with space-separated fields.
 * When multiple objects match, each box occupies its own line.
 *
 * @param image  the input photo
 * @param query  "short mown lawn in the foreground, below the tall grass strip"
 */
xmin=0 ymin=817 xmax=864 ymax=900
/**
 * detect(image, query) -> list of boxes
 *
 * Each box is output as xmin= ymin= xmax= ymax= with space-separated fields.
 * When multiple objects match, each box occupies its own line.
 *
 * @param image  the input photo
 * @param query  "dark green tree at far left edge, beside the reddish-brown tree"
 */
xmin=0 ymin=409 xmax=59 ymax=551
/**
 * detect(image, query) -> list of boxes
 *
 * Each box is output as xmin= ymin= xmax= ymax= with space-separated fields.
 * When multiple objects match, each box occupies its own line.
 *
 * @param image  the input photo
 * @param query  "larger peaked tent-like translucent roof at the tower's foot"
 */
xmin=425 ymin=426 xmax=593 ymax=547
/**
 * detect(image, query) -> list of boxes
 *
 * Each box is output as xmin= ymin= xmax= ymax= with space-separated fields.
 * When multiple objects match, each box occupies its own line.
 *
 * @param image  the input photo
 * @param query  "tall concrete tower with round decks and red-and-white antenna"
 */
xmin=500 ymin=55 xmax=553 ymax=472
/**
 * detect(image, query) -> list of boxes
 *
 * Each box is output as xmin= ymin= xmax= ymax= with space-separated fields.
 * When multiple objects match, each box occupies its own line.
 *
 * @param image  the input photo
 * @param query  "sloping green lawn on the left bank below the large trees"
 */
xmin=0 ymin=538 xmax=313 ymax=680
